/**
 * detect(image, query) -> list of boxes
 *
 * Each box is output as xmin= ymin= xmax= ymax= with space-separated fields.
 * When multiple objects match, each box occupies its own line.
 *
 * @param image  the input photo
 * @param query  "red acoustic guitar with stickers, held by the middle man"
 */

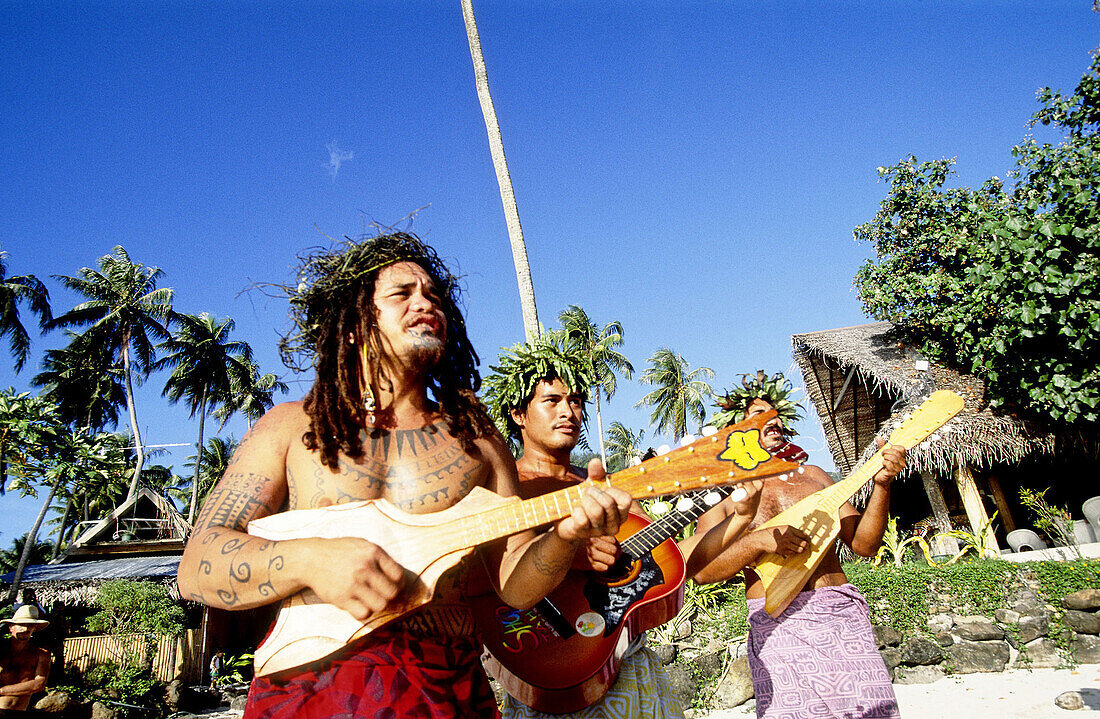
xmin=473 ymin=486 xmax=735 ymax=714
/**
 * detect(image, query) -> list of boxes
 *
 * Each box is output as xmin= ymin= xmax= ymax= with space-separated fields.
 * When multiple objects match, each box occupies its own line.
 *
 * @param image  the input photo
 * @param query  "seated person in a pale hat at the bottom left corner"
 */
xmin=0 ymin=605 xmax=50 ymax=716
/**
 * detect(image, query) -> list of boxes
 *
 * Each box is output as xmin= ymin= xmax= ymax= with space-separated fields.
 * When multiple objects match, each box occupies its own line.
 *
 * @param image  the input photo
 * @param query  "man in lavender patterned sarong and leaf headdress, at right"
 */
xmin=689 ymin=372 xmax=905 ymax=719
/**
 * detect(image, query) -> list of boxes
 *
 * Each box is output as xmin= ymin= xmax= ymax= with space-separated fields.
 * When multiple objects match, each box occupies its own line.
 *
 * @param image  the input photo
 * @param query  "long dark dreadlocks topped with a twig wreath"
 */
xmin=279 ymin=232 xmax=496 ymax=469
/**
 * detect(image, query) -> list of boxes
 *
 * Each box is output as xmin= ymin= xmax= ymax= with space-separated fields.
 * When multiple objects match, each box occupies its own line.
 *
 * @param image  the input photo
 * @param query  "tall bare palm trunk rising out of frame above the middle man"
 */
xmin=462 ymin=0 xmax=541 ymax=343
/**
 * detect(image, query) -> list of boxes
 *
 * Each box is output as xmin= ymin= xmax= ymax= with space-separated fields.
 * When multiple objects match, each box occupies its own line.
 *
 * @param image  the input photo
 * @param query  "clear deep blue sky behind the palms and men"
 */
xmin=0 ymin=0 xmax=1100 ymax=545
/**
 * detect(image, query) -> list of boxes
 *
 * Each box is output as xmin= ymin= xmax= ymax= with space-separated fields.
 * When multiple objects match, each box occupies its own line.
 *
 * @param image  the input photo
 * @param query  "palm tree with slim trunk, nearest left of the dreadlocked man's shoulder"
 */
xmin=155 ymin=312 xmax=252 ymax=522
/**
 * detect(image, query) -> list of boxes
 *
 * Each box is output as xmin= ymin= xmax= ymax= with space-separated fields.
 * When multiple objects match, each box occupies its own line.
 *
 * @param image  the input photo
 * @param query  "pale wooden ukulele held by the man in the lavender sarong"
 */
xmin=755 ymin=390 xmax=963 ymax=617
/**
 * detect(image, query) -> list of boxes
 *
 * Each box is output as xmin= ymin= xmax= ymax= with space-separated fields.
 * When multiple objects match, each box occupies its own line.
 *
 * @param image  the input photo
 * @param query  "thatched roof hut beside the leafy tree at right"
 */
xmin=791 ymin=322 xmax=1100 ymax=554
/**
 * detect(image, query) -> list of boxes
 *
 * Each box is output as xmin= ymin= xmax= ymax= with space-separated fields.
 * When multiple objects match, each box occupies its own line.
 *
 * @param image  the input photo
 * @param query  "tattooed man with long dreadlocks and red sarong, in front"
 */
xmin=178 ymin=233 xmax=630 ymax=719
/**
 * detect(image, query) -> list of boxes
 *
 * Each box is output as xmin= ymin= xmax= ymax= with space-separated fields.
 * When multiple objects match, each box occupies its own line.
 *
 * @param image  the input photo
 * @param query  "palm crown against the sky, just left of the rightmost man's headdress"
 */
xmin=635 ymin=347 xmax=714 ymax=442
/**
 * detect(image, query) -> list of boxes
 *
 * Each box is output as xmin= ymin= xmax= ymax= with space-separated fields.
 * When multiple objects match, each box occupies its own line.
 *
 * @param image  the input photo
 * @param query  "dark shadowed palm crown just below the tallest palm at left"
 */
xmin=31 ymin=330 xmax=127 ymax=432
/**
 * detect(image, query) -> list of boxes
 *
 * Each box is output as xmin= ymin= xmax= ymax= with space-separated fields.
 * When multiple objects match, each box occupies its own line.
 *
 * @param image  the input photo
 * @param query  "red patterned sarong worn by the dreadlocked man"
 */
xmin=244 ymin=624 xmax=499 ymax=719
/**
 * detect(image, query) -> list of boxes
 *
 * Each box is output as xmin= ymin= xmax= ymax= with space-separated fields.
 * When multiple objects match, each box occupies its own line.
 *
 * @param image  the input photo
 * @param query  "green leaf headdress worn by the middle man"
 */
xmin=482 ymin=332 xmax=592 ymax=443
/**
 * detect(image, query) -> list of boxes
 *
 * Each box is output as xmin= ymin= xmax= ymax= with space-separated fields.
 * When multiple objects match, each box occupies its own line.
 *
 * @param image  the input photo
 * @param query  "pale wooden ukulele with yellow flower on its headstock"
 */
xmin=249 ymin=411 xmax=798 ymax=676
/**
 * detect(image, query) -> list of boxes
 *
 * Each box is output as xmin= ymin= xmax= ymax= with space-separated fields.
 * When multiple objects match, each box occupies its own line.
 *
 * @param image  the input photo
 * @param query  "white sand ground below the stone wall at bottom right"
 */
xmin=704 ymin=664 xmax=1100 ymax=719
